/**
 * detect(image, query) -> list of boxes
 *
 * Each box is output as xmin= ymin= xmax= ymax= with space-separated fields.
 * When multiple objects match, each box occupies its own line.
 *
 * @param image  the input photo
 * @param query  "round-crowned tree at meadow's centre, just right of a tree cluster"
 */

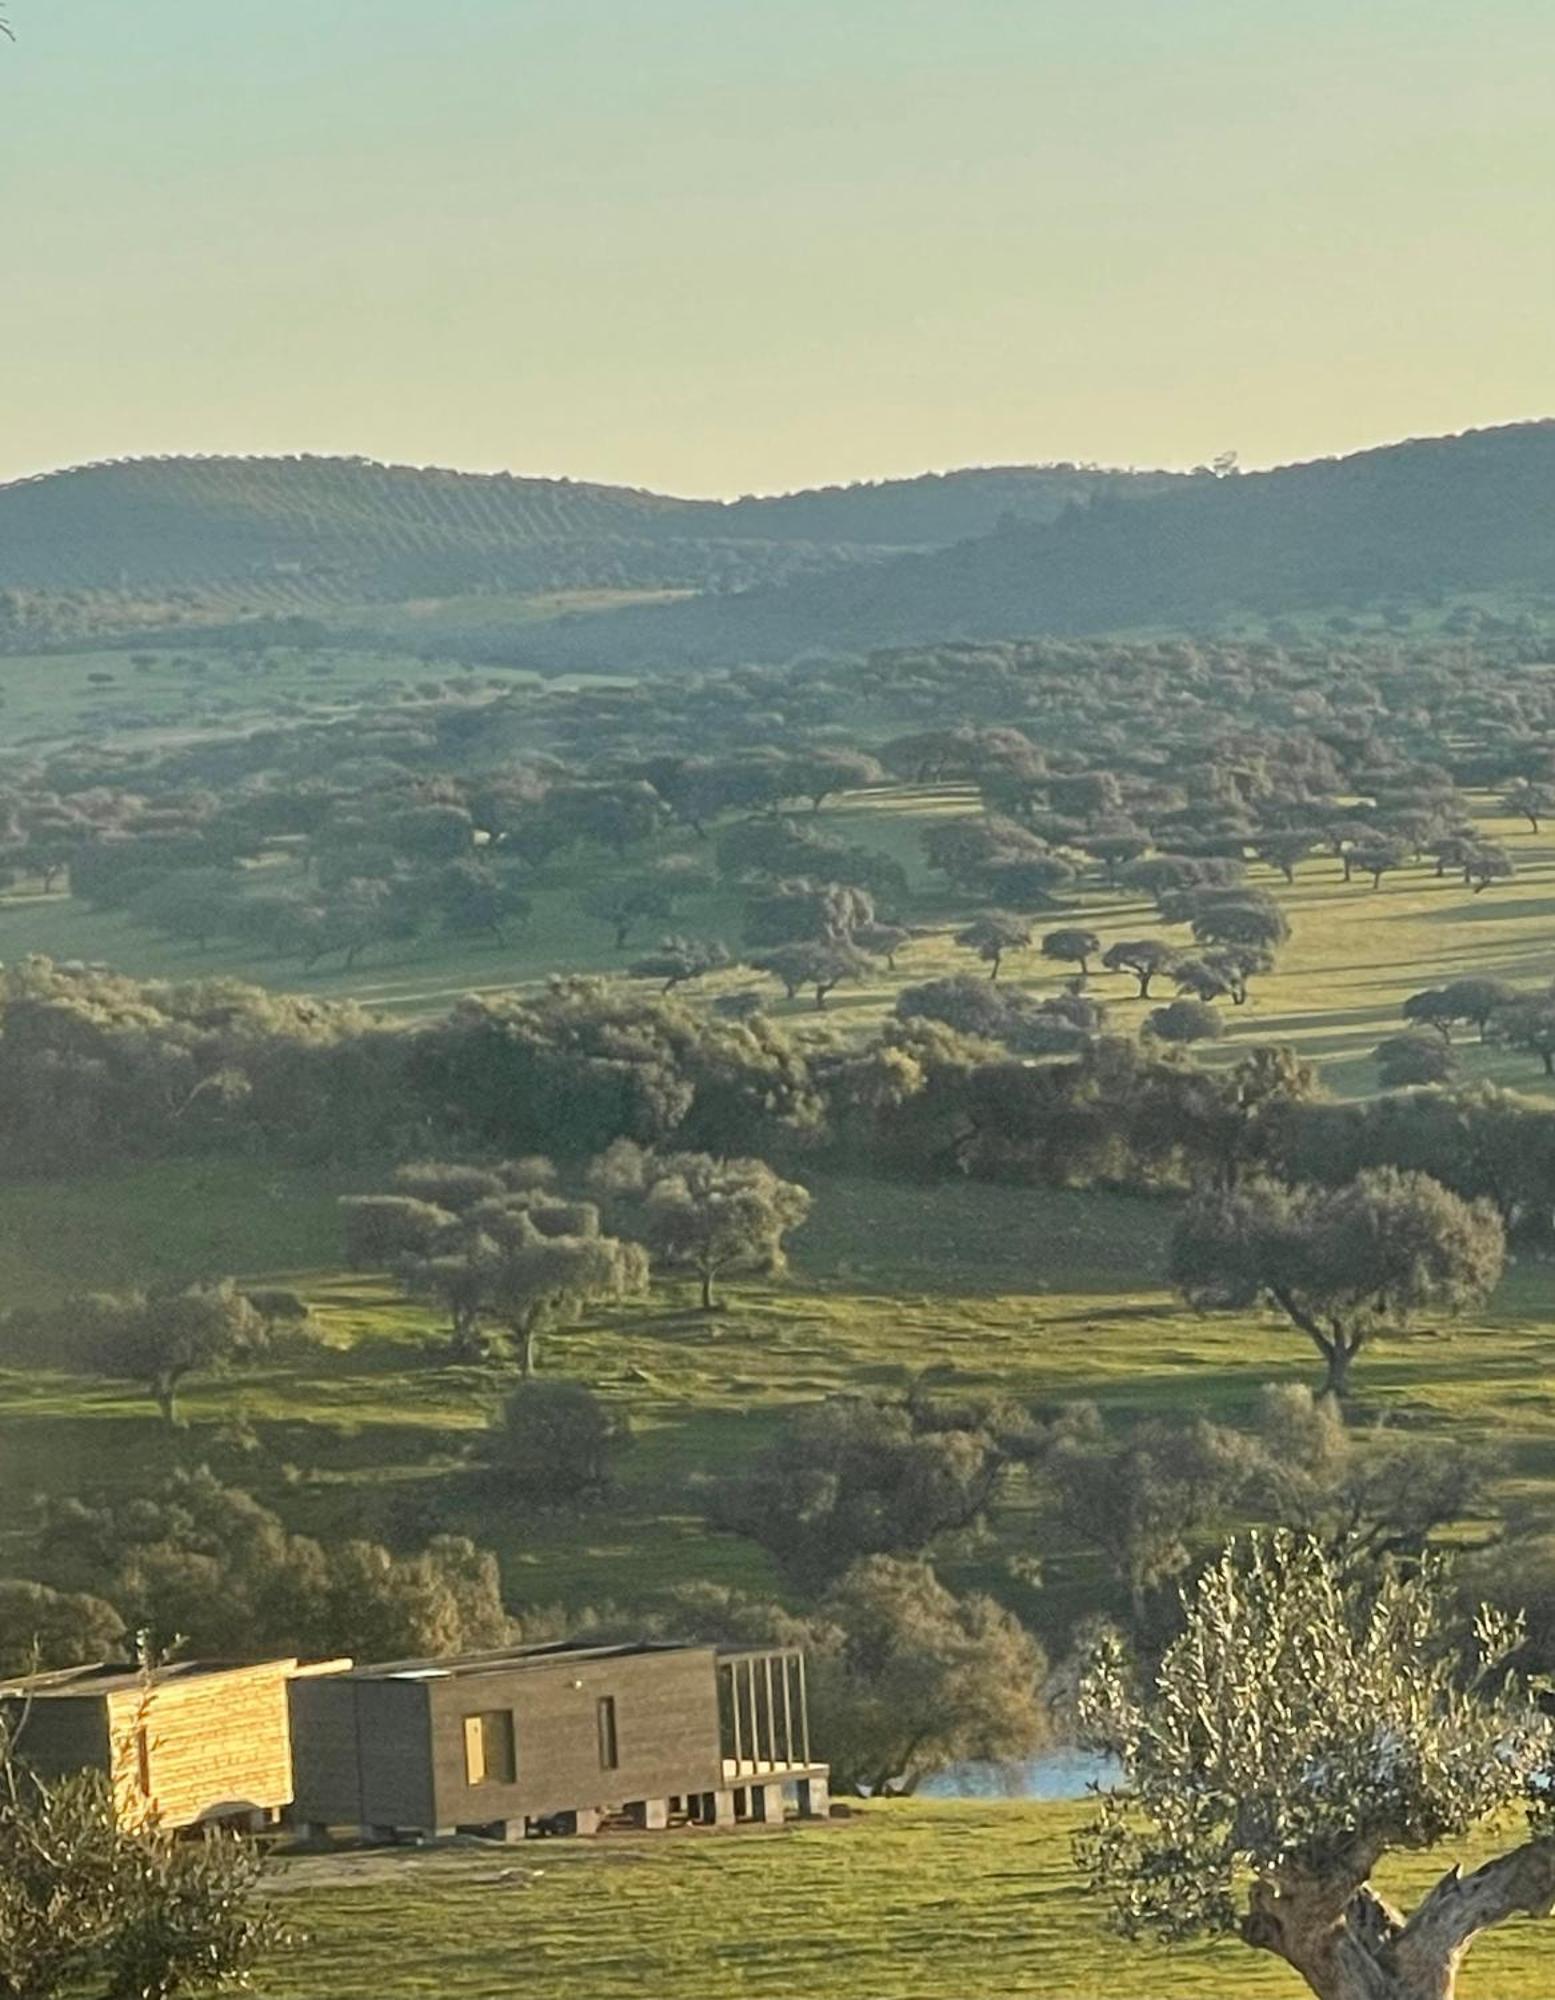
xmin=594 ymin=1140 xmax=809 ymax=1312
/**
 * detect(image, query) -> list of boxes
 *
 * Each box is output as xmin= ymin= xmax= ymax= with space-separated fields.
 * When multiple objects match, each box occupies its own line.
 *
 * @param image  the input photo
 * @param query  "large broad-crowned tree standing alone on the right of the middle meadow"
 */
xmin=1171 ymin=1166 xmax=1507 ymax=1396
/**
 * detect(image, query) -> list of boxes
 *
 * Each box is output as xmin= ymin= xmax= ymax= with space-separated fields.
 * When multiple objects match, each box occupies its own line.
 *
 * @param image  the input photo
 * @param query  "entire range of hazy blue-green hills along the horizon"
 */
xmin=0 ymin=422 xmax=1555 ymax=672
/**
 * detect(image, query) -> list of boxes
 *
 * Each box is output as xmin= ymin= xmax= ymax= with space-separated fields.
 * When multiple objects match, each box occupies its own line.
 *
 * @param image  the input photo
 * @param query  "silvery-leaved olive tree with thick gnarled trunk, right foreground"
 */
xmin=1077 ymin=1532 xmax=1555 ymax=2000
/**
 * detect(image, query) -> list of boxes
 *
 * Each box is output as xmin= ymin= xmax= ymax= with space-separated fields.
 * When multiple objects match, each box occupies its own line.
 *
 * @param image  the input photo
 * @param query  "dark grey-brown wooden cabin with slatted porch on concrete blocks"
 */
xmin=290 ymin=1644 xmax=827 ymax=1840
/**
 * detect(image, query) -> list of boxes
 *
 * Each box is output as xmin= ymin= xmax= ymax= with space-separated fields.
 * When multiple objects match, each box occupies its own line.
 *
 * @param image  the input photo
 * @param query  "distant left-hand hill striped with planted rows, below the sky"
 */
xmin=0 ymin=458 xmax=1169 ymax=616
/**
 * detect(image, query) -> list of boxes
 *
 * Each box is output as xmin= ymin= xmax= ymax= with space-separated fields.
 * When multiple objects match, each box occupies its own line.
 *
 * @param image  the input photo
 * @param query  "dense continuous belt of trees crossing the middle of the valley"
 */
xmin=12 ymin=960 xmax=1555 ymax=1240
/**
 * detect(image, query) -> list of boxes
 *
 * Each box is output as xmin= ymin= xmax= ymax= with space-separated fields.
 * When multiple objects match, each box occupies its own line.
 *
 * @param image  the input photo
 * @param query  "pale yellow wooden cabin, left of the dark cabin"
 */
xmin=0 ymin=1660 xmax=350 ymax=1828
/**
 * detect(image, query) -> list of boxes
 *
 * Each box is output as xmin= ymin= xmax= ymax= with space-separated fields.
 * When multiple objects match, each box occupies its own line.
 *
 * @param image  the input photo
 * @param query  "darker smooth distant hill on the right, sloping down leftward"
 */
xmin=491 ymin=422 xmax=1555 ymax=668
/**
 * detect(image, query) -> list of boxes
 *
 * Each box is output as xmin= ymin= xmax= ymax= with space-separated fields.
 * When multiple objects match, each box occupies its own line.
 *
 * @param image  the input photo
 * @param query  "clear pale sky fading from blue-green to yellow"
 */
xmin=0 ymin=0 xmax=1555 ymax=494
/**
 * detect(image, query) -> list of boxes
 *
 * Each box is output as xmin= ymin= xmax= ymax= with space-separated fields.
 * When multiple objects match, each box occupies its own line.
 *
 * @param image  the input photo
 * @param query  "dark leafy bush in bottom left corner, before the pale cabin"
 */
xmin=0 ymin=1722 xmax=280 ymax=2000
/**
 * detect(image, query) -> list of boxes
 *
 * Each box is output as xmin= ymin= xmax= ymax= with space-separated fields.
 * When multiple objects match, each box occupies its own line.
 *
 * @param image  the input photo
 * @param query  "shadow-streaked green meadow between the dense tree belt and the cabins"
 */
xmin=0 ymin=1168 xmax=1555 ymax=1644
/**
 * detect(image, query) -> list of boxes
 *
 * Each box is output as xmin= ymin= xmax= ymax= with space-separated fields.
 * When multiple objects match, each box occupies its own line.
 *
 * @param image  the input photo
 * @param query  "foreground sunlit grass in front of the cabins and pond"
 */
xmin=260 ymin=1802 xmax=1553 ymax=2000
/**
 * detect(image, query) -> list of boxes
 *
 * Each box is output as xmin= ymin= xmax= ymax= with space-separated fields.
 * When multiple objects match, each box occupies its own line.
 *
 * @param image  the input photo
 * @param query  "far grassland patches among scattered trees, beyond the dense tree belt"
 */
xmin=12 ymin=786 xmax=1555 ymax=1096
